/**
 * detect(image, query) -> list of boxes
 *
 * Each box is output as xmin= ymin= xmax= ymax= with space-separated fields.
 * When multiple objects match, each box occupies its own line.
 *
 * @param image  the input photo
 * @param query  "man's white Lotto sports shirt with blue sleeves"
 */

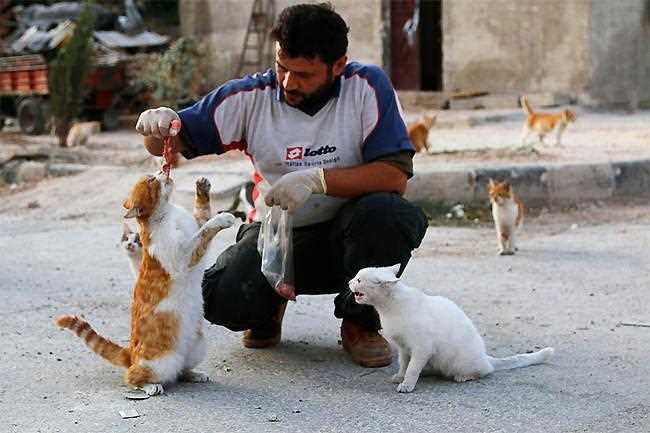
xmin=178 ymin=62 xmax=413 ymax=227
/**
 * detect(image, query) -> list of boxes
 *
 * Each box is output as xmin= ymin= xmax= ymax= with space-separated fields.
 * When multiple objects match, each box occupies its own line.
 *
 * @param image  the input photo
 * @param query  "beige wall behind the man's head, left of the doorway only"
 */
xmin=179 ymin=0 xmax=383 ymax=83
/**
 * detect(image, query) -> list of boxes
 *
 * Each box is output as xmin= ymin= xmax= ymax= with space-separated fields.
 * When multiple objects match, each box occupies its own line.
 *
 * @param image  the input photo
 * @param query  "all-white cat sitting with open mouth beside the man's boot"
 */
xmin=349 ymin=265 xmax=554 ymax=392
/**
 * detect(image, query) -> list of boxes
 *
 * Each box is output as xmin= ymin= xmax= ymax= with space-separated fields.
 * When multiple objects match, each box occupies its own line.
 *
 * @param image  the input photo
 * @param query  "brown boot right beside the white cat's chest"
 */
xmin=341 ymin=319 xmax=392 ymax=368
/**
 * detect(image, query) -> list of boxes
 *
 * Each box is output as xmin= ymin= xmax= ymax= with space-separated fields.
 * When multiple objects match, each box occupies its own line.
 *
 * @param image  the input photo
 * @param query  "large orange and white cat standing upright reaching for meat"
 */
xmin=56 ymin=173 xmax=235 ymax=395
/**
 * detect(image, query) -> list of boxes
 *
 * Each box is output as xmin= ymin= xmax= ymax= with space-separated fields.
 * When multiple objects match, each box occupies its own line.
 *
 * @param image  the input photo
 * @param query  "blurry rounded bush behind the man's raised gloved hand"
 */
xmin=142 ymin=38 xmax=210 ymax=109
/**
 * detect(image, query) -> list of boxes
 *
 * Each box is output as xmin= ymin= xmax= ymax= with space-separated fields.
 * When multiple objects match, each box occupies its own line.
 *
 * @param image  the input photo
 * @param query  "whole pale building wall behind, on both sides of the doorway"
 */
xmin=180 ymin=0 xmax=650 ymax=108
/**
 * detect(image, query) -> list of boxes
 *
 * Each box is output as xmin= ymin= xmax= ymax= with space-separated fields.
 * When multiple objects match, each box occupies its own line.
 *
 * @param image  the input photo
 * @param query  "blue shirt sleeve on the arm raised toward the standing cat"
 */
xmin=178 ymin=71 xmax=275 ymax=157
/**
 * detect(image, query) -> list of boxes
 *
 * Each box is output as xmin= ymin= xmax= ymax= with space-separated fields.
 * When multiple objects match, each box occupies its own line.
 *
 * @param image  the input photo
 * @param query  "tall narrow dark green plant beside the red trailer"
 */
xmin=48 ymin=0 xmax=95 ymax=146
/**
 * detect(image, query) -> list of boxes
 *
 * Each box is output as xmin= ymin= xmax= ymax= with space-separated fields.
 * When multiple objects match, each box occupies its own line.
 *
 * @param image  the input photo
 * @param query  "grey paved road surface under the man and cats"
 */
xmin=0 ymin=164 xmax=650 ymax=433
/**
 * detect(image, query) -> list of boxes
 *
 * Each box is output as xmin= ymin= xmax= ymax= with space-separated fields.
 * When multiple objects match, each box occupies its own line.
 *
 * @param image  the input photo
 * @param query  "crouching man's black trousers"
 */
xmin=202 ymin=193 xmax=427 ymax=331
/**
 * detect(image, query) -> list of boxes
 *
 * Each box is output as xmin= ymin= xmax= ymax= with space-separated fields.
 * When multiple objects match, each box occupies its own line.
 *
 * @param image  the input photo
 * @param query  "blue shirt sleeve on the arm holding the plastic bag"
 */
xmin=350 ymin=64 xmax=415 ymax=162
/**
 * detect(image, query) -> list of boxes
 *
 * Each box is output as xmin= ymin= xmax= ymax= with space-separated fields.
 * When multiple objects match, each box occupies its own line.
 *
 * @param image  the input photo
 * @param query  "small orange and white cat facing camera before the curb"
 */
xmin=488 ymin=179 xmax=524 ymax=256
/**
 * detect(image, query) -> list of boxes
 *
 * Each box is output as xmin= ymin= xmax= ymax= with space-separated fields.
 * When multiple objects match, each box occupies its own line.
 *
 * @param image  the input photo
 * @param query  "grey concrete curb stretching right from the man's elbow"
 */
xmin=405 ymin=159 xmax=650 ymax=206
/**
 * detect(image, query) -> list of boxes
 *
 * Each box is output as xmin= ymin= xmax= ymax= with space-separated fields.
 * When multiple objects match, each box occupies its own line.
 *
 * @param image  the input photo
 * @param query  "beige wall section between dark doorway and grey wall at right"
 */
xmin=442 ymin=0 xmax=588 ymax=94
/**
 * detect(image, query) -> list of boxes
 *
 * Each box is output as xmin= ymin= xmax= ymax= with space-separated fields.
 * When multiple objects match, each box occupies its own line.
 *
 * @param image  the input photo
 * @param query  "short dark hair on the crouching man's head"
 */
xmin=271 ymin=3 xmax=349 ymax=65
